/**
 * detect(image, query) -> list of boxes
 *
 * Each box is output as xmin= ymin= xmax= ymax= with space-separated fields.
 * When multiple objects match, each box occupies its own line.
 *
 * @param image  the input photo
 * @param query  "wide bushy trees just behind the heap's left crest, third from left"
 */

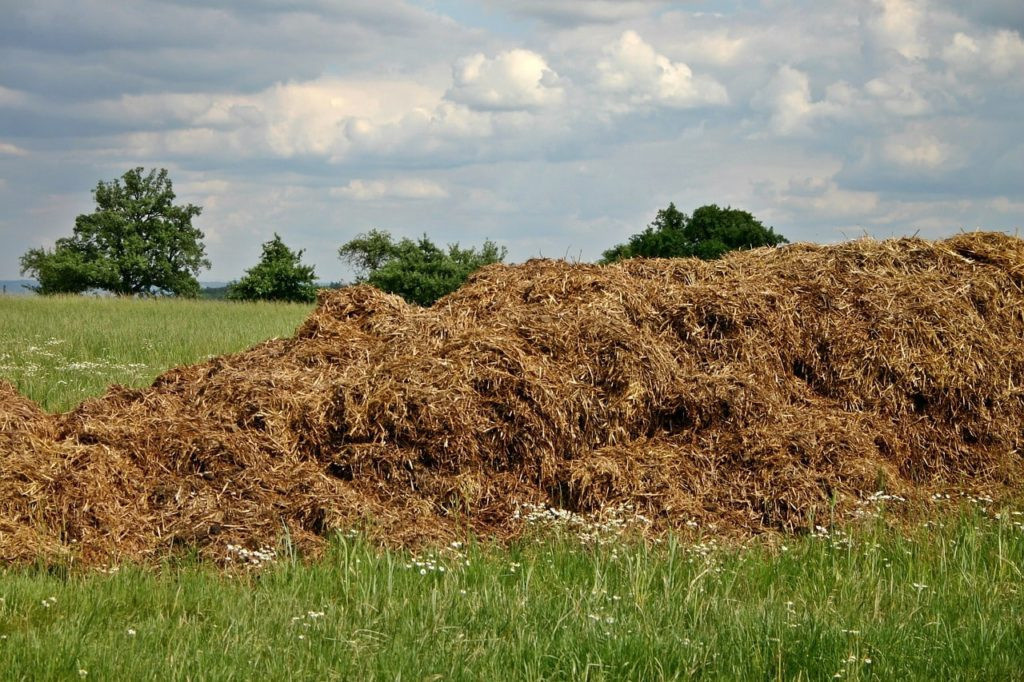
xmin=338 ymin=229 xmax=507 ymax=305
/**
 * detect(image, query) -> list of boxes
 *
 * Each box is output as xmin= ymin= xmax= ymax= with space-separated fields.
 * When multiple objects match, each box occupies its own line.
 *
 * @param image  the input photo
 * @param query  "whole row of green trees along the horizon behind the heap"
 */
xmin=20 ymin=168 xmax=786 ymax=305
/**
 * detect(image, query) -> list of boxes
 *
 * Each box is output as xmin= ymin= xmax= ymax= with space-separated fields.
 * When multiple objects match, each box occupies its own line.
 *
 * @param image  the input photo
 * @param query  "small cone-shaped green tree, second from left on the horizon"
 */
xmin=227 ymin=232 xmax=316 ymax=303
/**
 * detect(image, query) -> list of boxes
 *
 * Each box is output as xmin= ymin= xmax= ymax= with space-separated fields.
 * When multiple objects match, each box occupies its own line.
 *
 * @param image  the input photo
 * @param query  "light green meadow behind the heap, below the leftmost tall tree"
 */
xmin=0 ymin=296 xmax=312 ymax=412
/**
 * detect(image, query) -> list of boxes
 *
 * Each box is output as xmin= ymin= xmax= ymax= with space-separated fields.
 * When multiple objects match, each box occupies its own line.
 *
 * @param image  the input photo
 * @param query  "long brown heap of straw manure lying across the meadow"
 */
xmin=0 ymin=232 xmax=1024 ymax=564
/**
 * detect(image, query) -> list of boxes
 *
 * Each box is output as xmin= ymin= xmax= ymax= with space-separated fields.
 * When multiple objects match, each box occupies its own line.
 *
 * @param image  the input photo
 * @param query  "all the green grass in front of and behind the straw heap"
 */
xmin=0 ymin=298 xmax=1024 ymax=680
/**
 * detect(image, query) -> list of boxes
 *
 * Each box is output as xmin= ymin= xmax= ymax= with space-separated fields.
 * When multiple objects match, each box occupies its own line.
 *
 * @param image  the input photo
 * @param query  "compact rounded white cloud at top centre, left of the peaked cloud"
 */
xmin=446 ymin=49 xmax=563 ymax=111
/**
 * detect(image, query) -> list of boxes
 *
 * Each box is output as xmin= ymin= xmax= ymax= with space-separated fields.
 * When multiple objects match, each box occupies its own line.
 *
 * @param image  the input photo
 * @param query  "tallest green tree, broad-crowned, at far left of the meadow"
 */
xmin=22 ymin=168 xmax=210 ymax=297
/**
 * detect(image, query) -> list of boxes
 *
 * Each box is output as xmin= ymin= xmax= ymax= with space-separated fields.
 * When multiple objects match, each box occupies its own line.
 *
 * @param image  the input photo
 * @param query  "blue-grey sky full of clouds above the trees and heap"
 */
xmin=0 ymin=0 xmax=1024 ymax=281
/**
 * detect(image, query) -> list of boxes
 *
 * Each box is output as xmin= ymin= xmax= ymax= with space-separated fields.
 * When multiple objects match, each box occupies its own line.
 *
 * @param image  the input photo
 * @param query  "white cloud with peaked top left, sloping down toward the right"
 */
xmin=597 ymin=31 xmax=729 ymax=109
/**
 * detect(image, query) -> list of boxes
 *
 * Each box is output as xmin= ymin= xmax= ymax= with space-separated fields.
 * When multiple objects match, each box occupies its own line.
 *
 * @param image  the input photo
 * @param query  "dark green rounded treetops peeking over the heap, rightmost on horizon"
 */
xmin=601 ymin=204 xmax=786 ymax=263
